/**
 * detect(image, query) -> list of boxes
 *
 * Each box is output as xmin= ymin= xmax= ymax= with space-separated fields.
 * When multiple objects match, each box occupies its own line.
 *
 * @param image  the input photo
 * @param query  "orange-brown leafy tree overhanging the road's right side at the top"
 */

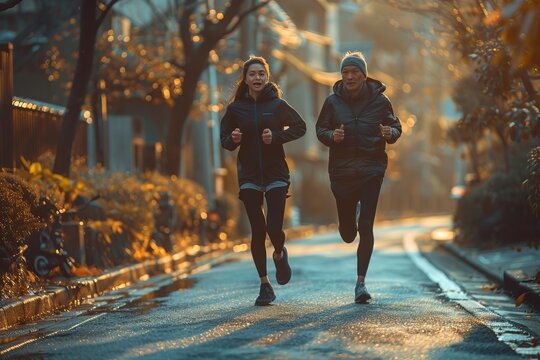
xmin=389 ymin=0 xmax=540 ymax=171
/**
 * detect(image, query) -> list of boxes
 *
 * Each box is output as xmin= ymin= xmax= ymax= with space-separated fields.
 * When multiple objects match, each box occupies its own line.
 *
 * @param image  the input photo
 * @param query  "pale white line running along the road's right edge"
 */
xmin=403 ymin=232 xmax=540 ymax=357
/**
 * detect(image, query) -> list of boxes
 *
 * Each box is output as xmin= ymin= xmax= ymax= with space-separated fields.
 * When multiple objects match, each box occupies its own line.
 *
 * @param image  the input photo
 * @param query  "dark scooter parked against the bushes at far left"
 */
xmin=24 ymin=196 xmax=98 ymax=277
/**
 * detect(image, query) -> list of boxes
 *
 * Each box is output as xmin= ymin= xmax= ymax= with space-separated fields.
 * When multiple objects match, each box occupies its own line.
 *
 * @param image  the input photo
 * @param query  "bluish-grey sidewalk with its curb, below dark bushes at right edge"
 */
xmin=440 ymin=235 xmax=540 ymax=309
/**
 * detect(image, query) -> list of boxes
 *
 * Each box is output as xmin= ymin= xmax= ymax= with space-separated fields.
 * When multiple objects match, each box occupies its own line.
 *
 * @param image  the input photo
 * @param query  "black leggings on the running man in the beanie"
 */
xmin=334 ymin=178 xmax=382 ymax=276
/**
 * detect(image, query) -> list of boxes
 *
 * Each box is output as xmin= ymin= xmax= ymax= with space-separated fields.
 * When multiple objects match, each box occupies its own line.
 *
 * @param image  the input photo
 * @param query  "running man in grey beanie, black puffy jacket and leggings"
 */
xmin=317 ymin=52 xmax=401 ymax=303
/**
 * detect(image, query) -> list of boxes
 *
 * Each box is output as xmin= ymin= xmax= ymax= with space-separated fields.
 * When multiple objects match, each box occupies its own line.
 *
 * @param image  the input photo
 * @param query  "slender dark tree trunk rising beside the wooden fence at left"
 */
xmin=53 ymin=0 xmax=97 ymax=176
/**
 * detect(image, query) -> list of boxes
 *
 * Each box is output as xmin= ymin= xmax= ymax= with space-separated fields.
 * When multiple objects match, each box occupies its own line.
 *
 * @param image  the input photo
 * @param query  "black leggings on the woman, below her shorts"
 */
xmin=240 ymin=186 xmax=287 ymax=277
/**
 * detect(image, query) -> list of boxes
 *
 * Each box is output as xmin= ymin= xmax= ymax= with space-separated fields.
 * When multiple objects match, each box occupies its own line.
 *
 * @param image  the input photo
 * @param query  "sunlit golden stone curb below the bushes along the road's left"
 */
xmin=0 ymin=225 xmax=317 ymax=330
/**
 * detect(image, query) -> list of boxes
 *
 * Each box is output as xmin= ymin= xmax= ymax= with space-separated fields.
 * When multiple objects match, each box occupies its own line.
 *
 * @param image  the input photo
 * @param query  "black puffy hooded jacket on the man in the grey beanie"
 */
xmin=316 ymin=78 xmax=401 ymax=180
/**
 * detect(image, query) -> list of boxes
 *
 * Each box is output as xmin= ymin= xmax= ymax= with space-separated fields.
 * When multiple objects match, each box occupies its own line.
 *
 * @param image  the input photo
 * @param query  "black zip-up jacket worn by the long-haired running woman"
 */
xmin=221 ymin=83 xmax=306 ymax=186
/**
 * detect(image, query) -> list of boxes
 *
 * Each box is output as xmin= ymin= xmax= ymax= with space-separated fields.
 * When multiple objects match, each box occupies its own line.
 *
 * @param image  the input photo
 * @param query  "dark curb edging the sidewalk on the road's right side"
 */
xmin=440 ymin=242 xmax=540 ymax=309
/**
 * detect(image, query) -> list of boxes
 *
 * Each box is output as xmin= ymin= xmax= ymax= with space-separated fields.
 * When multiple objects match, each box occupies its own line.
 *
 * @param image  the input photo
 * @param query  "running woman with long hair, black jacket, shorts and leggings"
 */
xmin=221 ymin=57 xmax=306 ymax=306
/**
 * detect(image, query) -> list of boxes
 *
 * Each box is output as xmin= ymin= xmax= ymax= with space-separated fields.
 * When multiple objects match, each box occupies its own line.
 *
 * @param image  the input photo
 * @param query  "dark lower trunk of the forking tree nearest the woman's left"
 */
xmin=165 ymin=57 xmax=208 ymax=175
